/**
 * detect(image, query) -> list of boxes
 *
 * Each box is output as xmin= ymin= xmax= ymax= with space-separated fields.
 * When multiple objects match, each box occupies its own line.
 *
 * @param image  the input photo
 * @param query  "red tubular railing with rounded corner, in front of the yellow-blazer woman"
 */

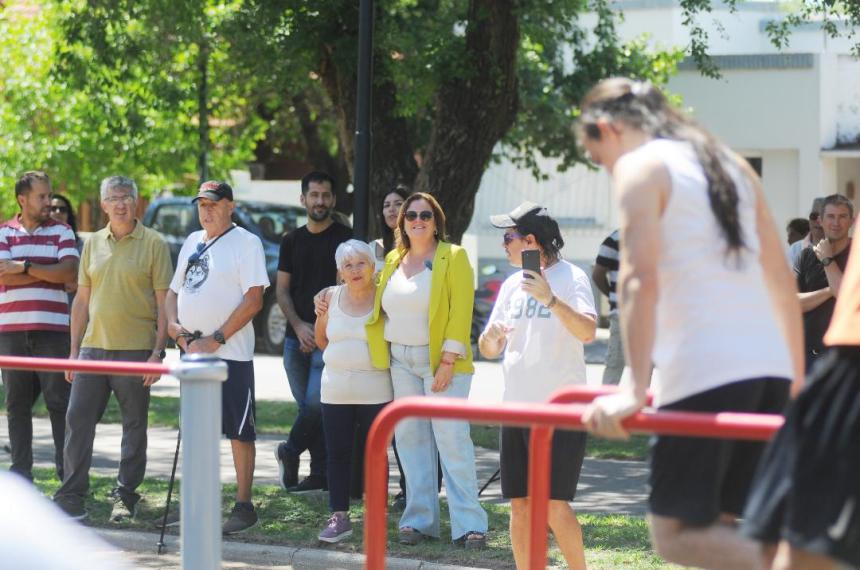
xmin=364 ymin=397 xmax=783 ymax=570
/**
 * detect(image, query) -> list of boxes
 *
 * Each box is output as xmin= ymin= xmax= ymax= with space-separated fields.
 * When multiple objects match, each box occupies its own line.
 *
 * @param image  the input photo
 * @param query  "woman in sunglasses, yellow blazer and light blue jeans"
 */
xmin=366 ymin=192 xmax=487 ymax=548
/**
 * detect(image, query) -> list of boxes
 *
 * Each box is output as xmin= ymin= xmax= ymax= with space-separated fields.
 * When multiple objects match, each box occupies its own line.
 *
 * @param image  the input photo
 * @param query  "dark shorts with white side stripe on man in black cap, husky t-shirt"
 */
xmin=221 ymin=360 xmax=257 ymax=441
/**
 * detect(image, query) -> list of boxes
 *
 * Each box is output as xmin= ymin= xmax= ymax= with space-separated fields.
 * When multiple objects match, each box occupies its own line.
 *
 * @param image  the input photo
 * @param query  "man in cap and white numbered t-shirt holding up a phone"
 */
xmin=479 ymin=202 xmax=597 ymax=569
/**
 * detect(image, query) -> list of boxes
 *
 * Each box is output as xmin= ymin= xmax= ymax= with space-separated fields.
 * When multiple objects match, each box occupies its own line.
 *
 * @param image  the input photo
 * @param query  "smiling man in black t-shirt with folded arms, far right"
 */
xmin=794 ymin=194 xmax=854 ymax=370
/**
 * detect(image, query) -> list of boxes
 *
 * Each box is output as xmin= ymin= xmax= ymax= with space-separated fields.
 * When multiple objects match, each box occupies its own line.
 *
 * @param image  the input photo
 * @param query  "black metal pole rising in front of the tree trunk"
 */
xmin=352 ymin=0 xmax=373 ymax=241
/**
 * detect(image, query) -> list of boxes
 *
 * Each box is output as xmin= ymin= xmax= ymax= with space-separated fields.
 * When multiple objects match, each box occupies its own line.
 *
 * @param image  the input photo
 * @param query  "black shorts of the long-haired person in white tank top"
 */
xmin=648 ymin=378 xmax=790 ymax=526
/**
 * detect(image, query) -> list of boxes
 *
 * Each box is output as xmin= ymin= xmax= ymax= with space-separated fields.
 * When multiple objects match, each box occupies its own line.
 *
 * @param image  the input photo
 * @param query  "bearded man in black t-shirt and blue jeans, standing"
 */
xmin=275 ymin=172 xmax=352 ymax=491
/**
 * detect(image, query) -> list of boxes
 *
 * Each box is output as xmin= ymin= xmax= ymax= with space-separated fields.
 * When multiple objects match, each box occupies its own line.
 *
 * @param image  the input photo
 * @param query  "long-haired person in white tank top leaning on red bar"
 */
xmin=579 ymin=78 xmax=804 ymax=568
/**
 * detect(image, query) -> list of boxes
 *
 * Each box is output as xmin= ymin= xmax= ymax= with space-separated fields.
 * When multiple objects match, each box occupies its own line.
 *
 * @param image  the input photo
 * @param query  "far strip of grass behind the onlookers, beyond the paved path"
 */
xmin=0 ymin=386 xmax=648 ymax=460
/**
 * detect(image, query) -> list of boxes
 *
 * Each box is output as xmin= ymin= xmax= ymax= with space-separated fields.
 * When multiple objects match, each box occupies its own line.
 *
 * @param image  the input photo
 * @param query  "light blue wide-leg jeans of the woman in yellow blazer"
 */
xmin=391 ymin=344 xmax=487 ymax=539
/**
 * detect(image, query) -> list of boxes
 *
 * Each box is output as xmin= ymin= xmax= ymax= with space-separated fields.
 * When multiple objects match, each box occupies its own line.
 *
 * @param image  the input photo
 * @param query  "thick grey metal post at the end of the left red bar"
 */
xmin=172 ymin=354 xmax=227 ymax=570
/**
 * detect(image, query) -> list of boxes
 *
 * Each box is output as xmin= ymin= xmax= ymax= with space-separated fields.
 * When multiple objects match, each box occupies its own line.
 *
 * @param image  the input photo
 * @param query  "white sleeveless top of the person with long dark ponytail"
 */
xmin=633 ymin=139 xmax=793 ymax=406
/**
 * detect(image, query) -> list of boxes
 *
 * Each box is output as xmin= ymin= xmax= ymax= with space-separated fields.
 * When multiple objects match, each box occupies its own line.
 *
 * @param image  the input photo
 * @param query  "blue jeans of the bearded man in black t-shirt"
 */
xmin=284 ymin=337 xmax=326 ymax=476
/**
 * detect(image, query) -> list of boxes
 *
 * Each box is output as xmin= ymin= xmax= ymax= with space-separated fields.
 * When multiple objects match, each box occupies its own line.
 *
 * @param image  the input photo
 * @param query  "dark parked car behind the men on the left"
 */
xmin=143 ymin=197 xmax=307 ymax=354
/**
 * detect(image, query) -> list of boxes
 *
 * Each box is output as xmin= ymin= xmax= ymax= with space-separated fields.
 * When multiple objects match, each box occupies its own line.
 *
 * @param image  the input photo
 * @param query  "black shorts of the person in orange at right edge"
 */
xmin=742 ymin=347 xmax=860 ymax=566
